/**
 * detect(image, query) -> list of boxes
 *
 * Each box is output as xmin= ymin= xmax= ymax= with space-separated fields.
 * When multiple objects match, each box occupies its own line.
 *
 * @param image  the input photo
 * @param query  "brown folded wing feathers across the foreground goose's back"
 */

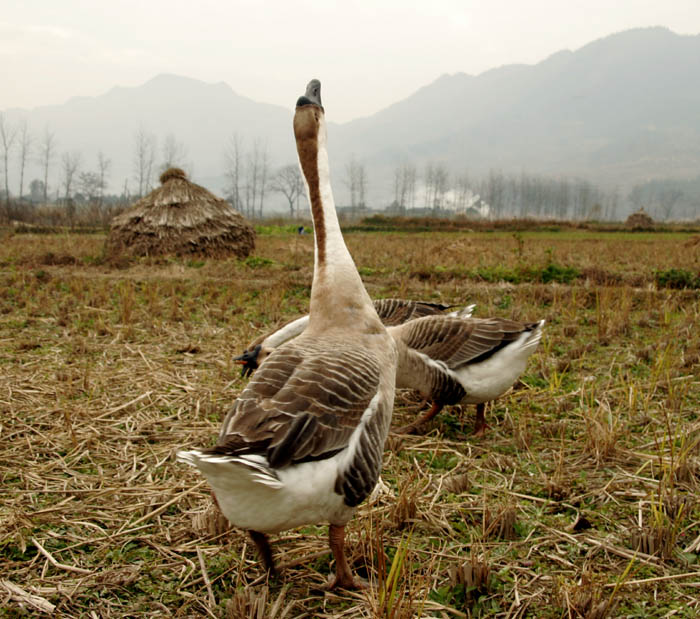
xmin=209 ymin=340 xmax=381 ymax=469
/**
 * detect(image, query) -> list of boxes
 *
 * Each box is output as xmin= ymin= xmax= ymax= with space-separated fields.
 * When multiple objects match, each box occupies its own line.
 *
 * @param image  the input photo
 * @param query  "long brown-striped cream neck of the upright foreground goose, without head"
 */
xmin=297 ymin=116 xmax=378 ymax=329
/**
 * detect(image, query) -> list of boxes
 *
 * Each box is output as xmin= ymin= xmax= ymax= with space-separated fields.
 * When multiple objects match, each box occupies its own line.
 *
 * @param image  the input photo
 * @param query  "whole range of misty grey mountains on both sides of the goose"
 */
xmin=8 ymin=28 xmax=700 ymax=213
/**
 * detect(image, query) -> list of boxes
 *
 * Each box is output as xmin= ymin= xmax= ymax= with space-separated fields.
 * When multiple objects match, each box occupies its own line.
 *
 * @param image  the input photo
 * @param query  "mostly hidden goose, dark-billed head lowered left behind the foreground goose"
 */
xmin=234 ymin=299 xmax=475 ymax=376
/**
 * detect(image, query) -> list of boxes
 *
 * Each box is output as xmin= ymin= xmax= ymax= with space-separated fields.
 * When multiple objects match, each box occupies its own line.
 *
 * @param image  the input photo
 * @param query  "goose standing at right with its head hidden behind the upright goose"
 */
xmin=387 ymin=316 xmax=544 ymax=436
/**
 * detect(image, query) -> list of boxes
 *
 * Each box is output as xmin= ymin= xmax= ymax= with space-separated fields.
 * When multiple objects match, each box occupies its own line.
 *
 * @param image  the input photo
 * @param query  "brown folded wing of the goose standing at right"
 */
xmin=401 ymin=316 xmax=538 ymax=369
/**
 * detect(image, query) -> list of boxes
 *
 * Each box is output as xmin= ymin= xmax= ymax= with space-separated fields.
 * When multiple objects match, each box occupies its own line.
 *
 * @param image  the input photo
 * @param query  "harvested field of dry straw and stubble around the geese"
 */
xmin=0 ymin=227 xmax=700 ymax=619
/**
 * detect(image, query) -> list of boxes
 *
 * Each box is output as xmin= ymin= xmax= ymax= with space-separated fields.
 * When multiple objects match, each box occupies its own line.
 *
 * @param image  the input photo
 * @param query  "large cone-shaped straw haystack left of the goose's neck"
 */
xmin=107 ymin=168 xmax=255 ymax=258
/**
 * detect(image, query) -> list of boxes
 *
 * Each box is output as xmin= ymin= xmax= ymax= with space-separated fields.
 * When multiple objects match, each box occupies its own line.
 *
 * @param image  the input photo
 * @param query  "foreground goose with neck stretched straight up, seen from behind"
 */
xmin=177 ymin=80 xmax=397 ymax=589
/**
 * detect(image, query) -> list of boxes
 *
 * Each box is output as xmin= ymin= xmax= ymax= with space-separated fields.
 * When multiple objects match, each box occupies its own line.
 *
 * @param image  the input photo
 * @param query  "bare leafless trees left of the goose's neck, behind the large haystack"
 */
xmin=0 ymin=113 xmax=312 ymax=225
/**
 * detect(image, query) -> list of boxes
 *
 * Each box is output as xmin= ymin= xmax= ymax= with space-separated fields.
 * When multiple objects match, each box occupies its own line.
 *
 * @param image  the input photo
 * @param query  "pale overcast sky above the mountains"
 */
xmin=0 ymin=0 xmax=700 ymax=122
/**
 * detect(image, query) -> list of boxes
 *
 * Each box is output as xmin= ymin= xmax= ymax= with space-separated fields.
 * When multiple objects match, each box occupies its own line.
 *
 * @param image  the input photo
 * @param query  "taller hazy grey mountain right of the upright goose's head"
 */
xmin=332 ymin=28 xmax=700 ymax=194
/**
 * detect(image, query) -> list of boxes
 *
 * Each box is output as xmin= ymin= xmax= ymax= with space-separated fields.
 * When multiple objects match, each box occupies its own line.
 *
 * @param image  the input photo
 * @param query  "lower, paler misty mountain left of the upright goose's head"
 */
xmin=1 ymin=74 xmax=296 ymax=199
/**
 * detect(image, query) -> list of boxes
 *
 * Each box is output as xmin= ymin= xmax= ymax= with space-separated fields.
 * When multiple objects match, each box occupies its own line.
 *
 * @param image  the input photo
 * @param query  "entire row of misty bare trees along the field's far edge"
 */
xmin=0 ymin=113 xmax=700 ymax=225
